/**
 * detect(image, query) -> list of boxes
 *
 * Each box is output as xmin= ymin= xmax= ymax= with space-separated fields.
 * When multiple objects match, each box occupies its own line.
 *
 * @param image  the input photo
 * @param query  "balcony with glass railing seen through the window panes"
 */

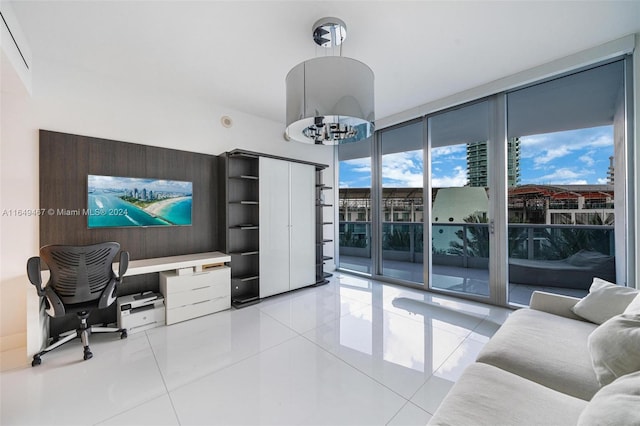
xmin=340 ymin=222 xmax=615 ymax=305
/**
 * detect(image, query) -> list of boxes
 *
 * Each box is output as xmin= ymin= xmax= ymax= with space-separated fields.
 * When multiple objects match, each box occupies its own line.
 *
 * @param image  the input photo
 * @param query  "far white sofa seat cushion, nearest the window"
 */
xmin=478 ymin=309 xmax=600 ymax=400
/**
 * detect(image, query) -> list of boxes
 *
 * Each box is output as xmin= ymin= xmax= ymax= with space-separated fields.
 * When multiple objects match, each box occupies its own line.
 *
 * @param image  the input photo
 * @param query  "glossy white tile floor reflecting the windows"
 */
xmin=0 ymin=273 xmax=511 ymax=425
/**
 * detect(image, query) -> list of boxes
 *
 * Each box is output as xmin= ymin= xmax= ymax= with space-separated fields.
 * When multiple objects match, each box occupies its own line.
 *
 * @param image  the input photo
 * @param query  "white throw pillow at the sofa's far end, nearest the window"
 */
xmin=571 ymin=278 xmax=639 ymax=324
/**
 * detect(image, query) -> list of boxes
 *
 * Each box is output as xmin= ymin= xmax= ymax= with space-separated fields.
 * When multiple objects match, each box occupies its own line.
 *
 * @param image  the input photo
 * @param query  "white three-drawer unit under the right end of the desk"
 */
xmin=160 ymin=266 xmax=231 ymax=325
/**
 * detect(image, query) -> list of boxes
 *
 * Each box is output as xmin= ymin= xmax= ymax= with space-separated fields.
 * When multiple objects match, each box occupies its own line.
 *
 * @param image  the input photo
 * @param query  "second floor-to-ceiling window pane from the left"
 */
xmin=380 ymin=120 xmax=425 ymax=283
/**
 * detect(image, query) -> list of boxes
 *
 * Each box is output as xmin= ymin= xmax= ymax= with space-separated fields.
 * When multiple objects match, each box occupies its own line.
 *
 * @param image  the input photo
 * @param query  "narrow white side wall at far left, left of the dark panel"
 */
xmin=0 ymin=49 xmax=38 ymax=369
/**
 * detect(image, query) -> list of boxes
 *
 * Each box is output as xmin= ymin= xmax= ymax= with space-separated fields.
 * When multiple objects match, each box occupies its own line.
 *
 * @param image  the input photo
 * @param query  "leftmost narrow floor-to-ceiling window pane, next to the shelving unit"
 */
xmin=336 ymin=138 xmax=373 ymax=274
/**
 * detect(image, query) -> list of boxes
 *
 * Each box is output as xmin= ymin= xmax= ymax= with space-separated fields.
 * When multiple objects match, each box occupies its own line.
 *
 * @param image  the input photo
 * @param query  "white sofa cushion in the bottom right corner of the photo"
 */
xmin=578 ymin=371 xmax=640 ymax=426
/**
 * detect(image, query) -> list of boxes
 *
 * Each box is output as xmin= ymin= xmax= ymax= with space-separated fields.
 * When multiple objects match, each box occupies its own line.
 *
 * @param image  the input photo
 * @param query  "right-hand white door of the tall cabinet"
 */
xmin=289 ymin=163 xmax=316 ymax=290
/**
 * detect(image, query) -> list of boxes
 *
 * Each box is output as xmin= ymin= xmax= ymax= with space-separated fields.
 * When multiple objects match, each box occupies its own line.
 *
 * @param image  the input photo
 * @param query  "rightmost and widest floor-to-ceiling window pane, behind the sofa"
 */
xmin=507 ymin=61 xmax=625 ymax=305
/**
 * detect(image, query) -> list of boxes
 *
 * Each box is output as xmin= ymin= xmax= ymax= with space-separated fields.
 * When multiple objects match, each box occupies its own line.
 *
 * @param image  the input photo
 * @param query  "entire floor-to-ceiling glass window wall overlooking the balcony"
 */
xmin=337 ymin=55 xmax=634 ymax=305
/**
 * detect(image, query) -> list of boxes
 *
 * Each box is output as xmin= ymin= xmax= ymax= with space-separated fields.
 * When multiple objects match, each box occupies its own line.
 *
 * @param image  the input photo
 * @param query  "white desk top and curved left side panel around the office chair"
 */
xmin=26 ymin=251 xmax=231 ymax=358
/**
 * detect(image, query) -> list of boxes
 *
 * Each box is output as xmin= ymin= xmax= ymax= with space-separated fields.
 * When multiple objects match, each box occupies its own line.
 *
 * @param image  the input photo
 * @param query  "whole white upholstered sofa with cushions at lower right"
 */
xmin=429 ymin=279 xmax=640 ymax=426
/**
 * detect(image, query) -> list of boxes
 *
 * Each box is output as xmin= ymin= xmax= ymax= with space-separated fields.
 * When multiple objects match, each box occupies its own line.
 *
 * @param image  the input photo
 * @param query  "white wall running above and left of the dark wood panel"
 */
xmin=0 ymin=52 xmax=333 ymax=368
